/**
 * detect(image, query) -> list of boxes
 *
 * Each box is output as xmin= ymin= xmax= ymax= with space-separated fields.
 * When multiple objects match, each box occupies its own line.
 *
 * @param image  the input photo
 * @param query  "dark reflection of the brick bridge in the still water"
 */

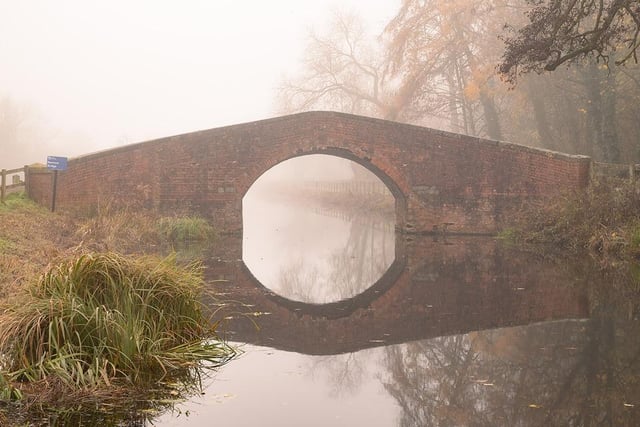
xmin=205 ymin=235 xmax=589 ymax=355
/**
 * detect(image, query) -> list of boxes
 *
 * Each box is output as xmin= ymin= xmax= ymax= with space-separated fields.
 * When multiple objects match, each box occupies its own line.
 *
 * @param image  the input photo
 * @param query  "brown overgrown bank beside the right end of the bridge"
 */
xmin=500 ymin=179 xmax=640 ymax=265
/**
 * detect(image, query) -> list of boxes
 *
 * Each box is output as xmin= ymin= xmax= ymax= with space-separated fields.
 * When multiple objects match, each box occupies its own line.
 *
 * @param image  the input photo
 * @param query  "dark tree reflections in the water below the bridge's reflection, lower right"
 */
xmin=384 ymin=315 xmax=640 ymax=426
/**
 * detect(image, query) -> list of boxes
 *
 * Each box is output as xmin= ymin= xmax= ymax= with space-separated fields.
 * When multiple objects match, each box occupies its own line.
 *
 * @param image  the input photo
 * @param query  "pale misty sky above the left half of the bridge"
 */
xmin=0 ymin=0 xmax=399 ymax=164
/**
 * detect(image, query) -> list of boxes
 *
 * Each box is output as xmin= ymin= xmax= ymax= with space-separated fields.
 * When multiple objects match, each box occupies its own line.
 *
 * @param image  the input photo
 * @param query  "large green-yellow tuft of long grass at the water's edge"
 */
xmin=0 ymin=253 xmax=235 ymax=389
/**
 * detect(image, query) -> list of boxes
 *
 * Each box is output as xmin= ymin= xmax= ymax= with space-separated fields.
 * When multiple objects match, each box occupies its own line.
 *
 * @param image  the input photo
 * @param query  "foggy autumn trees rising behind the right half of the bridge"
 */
xmin=279 ymin=0 xmax=640 ymax=162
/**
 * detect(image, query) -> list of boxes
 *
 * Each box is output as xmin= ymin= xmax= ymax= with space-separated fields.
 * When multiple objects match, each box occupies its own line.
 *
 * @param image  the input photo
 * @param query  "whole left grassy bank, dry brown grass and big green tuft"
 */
xmin=0 ymin=195 xmax=234 ymax=421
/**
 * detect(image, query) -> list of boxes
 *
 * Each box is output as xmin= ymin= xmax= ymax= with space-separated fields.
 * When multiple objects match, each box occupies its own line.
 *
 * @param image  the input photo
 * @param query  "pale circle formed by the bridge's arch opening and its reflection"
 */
xmin=242 ymin=151 xmax=404 ymax=304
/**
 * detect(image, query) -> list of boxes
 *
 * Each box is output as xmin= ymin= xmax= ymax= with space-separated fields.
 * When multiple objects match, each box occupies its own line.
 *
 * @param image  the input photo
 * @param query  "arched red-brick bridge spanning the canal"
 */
xmin=26 ymin=112 xmax=590 ymax=233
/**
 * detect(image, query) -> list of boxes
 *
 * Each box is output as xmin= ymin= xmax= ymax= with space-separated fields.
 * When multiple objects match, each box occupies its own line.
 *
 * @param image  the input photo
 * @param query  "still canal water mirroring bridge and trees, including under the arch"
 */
xmin=152 ymin=192 xmax=640 ymax=426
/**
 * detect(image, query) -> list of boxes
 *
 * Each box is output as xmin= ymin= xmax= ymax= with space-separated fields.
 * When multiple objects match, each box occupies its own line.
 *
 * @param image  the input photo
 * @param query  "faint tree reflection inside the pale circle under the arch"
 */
xmin=279 ymin=211 xmax=395 ymax=303
